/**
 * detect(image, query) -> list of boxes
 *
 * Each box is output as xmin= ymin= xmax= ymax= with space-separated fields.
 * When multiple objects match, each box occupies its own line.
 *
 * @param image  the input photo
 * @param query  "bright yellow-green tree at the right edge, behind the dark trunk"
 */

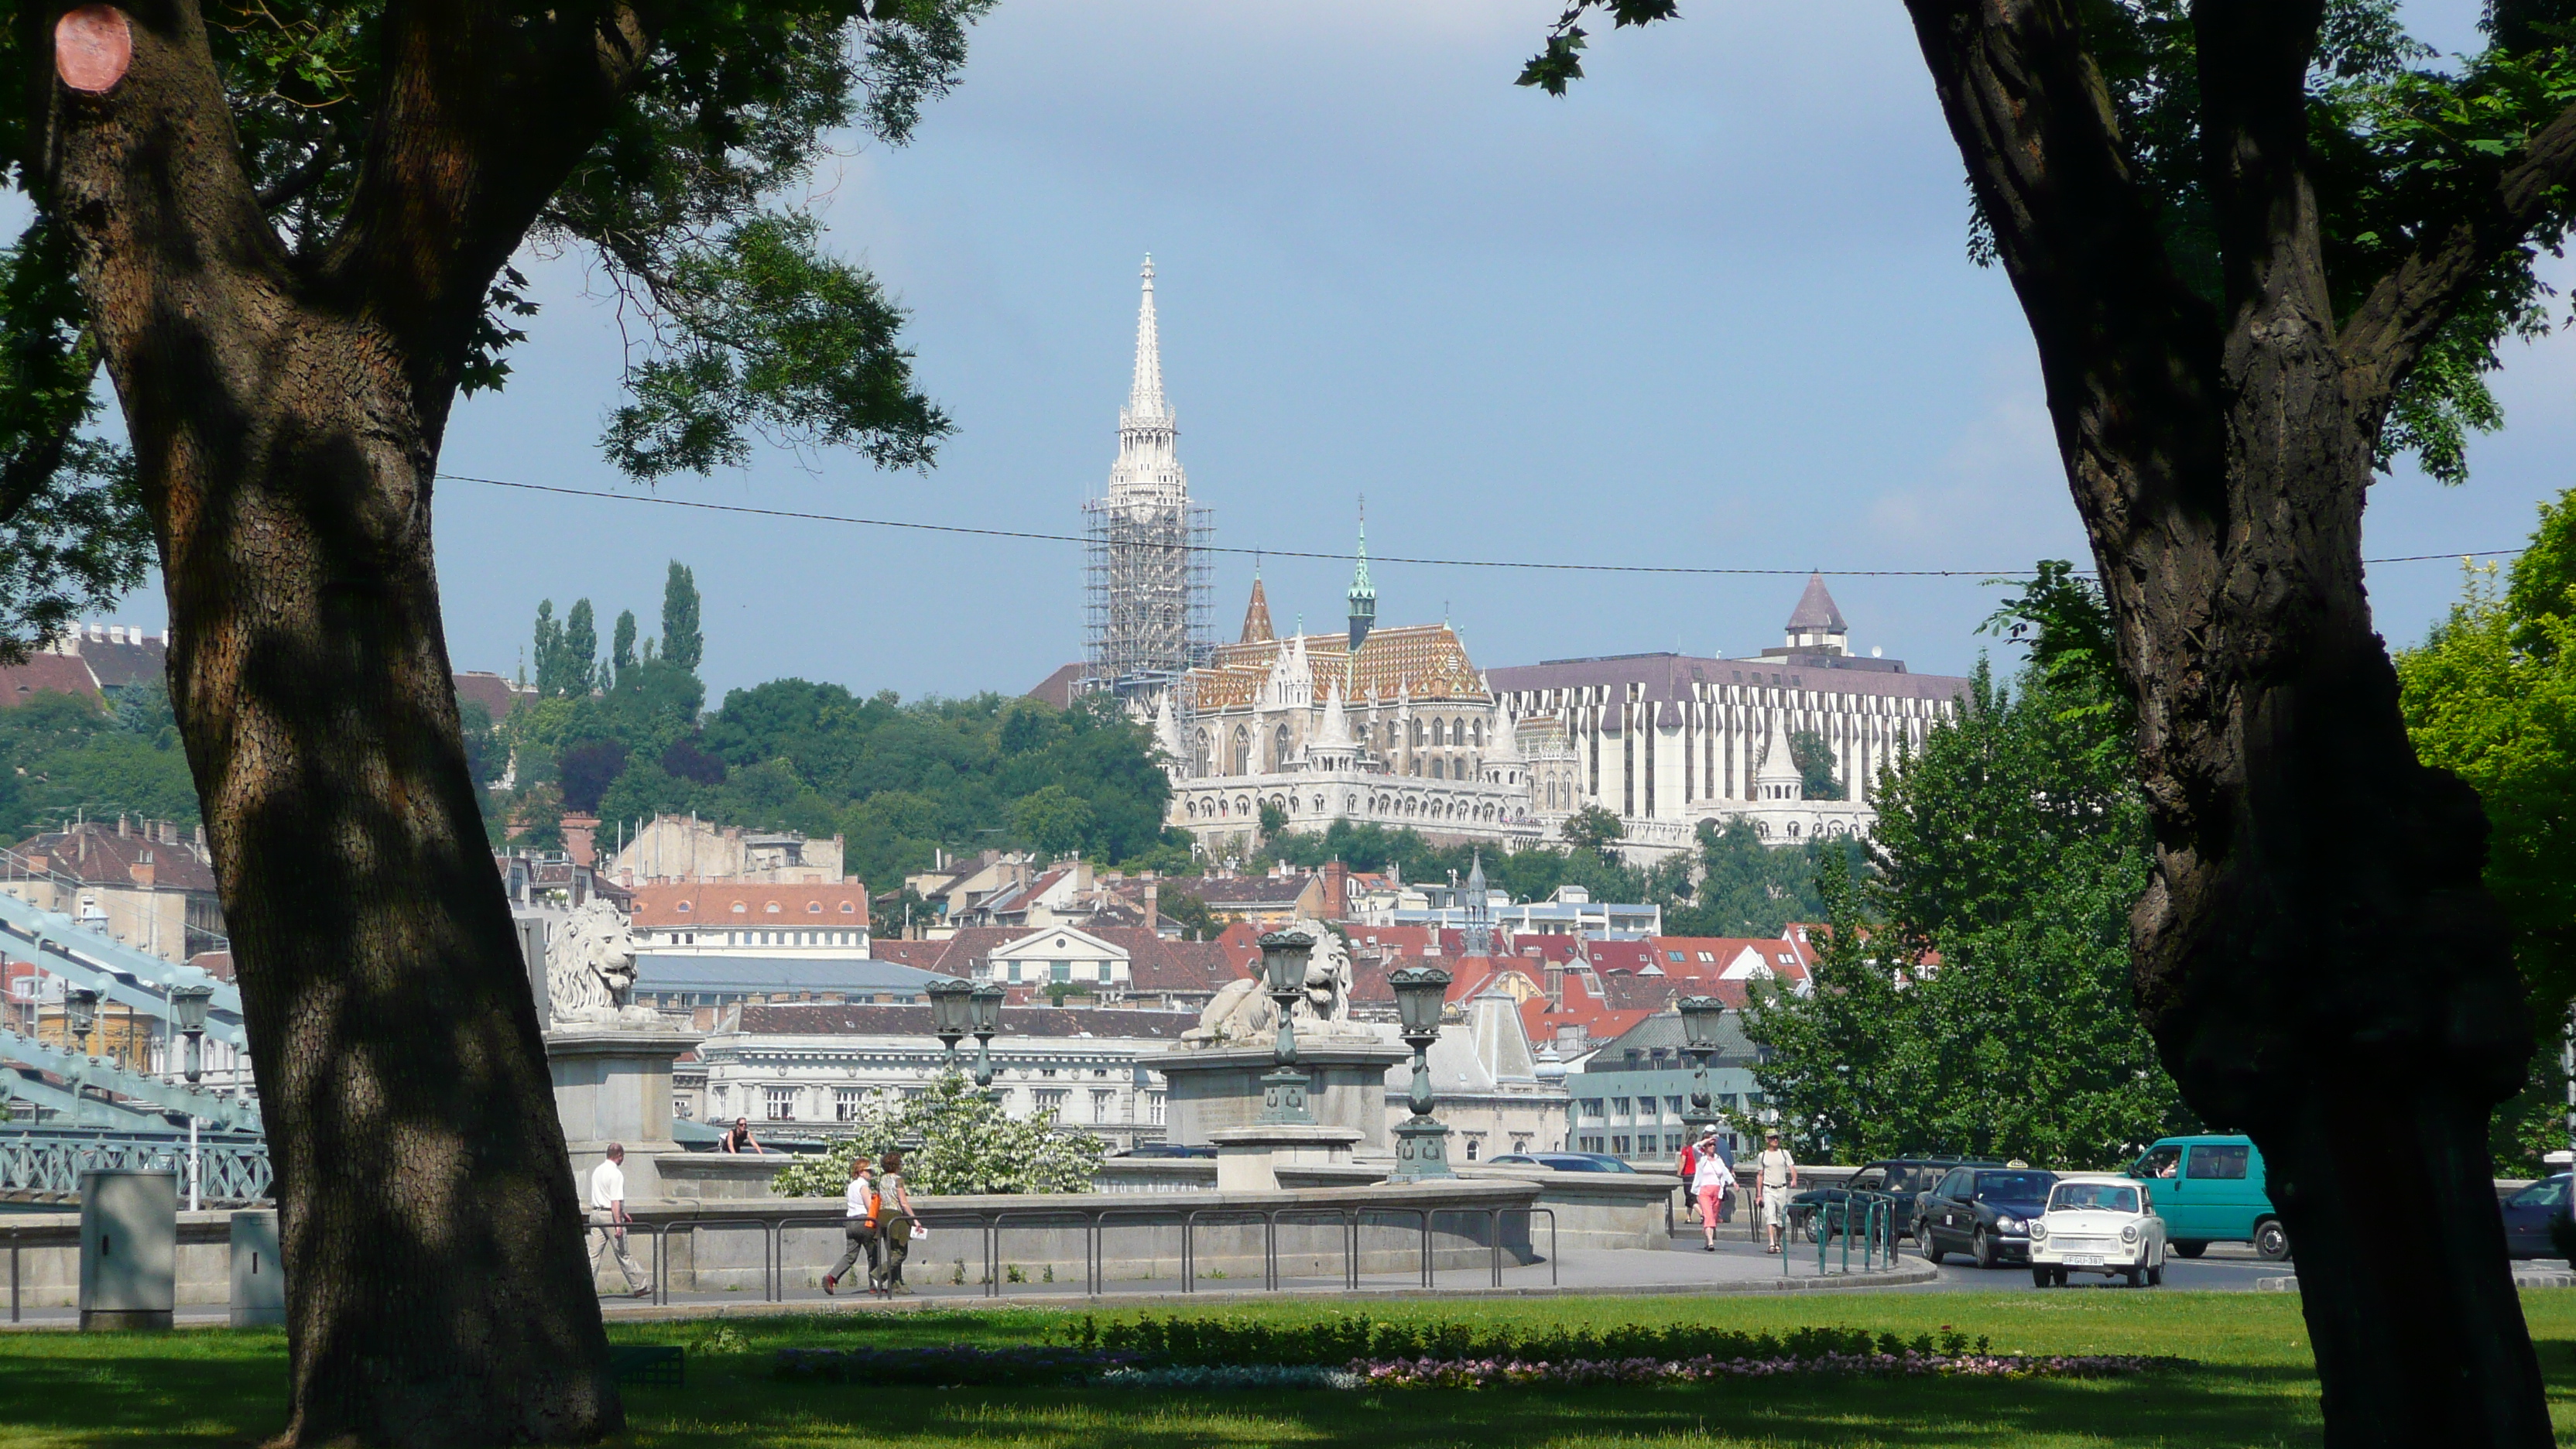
xmin=2396 ymin=502 xmax=2576 ymax=1170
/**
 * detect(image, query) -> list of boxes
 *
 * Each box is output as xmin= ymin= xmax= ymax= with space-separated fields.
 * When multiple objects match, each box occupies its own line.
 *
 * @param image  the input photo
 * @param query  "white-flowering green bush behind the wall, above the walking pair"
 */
xmin=770 ymin=1073 xmax=1108 ymax=1197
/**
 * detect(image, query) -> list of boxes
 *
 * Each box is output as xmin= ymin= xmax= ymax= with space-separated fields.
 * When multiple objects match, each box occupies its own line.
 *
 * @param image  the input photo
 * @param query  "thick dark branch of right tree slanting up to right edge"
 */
xmin=2339 ymin=106 xmax=2576 ymax=418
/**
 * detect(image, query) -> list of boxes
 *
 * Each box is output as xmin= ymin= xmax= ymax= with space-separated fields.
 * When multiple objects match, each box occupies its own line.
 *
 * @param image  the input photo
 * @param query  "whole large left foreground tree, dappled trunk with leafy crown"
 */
xmin=0 ymin=0 xmax=987 ymax=1444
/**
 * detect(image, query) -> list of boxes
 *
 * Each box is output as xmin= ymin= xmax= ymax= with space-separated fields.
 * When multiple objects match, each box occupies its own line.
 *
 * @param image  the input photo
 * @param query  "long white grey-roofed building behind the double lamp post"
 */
xmin=673 ymin=1005 xmax=1198 ymax=1147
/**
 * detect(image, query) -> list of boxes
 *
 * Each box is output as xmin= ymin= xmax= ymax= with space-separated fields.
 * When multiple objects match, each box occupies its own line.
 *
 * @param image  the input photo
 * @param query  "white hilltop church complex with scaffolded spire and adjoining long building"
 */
xmin=1059 ymin=258 xmax=1968 ymax=858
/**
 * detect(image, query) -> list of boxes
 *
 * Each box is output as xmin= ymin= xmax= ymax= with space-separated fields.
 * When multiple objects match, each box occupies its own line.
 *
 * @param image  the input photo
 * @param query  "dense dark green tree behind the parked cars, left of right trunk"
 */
xmin=1746 ymin=574 xmax=2190 ymax=1168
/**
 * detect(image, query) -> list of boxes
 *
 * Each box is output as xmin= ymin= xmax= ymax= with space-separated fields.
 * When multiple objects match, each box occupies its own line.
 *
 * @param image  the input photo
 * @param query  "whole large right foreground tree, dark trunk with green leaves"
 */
xmin=1525 ymin=0 xmax=2576 ymax=1447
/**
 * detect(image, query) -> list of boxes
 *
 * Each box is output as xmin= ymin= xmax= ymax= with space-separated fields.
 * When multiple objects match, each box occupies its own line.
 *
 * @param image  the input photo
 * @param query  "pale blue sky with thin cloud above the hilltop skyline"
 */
xmin=80 ymin=0 xmax=2576 ymax=699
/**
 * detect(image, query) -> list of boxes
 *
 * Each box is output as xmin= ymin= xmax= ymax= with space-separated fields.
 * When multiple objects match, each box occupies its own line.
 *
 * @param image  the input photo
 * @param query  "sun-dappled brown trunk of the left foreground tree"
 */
xmin=39 ymin=0 xmax=623 ymax=1447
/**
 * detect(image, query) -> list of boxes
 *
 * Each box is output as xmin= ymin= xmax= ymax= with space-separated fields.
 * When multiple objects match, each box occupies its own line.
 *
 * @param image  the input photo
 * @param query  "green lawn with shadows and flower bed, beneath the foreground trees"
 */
xmin=0 ymin=1292 xmax=2576 ymax=1449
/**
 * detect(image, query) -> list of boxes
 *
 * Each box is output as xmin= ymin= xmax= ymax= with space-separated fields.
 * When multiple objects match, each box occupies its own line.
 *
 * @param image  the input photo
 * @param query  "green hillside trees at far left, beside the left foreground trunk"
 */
xmin=0 ymin=680 xmax=198 ymax=843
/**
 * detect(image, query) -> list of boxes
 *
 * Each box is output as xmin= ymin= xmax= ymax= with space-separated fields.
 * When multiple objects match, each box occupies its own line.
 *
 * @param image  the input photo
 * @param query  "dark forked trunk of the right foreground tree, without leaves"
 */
xmin=1909 ymin=0 xmax=2550 ymax=1449
